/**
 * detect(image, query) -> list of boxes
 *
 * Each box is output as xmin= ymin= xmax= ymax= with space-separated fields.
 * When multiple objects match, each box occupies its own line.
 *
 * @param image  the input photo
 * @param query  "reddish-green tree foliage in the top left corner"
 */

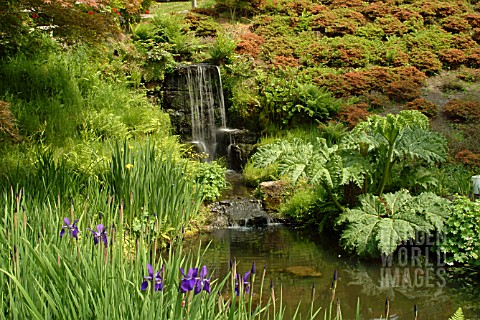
xmin=0 ymin=0 xmax=149 ymax=54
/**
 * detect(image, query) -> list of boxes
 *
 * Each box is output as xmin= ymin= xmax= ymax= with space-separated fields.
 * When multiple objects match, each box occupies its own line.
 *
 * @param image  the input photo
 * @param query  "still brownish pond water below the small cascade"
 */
xmin=183 ymin=224 xmax=475 ymax=320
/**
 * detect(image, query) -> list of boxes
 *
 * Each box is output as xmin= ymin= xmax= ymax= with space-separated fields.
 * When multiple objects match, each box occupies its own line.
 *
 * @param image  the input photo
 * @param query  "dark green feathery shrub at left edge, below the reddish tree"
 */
xmin=0 ymin=53 xmax=83 ymax=140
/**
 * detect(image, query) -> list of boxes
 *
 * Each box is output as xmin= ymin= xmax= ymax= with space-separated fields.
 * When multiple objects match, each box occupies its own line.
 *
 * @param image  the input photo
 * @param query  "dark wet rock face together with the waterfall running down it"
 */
xmin=161 ymin=64 xmax=257 ymax=170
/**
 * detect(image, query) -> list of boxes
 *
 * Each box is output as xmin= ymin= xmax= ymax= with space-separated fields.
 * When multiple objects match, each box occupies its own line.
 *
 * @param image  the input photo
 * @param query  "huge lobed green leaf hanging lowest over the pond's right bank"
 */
xmin=336 ymin=190 xmax=449 ymax=256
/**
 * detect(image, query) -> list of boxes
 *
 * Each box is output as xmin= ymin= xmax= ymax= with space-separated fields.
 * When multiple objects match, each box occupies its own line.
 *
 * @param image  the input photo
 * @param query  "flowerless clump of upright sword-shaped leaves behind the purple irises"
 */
xmin=104 ymin=141 xmax=203 ymax=236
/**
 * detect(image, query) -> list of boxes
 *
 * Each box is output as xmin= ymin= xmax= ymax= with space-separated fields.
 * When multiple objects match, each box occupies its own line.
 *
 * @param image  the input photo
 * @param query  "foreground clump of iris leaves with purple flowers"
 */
xmin=0 ymin=182 xmax=342 ymax=319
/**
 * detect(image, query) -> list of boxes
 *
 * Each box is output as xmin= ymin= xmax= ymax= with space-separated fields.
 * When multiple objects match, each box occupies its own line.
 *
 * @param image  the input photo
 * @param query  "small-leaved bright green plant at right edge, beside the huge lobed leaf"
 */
xmin=443 ymin=196 xmax=480 ymax=267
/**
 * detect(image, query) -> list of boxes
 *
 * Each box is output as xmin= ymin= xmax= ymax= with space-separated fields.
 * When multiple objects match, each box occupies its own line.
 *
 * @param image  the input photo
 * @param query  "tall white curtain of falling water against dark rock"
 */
xmin=187 ymin=64 xmax=227 ymax=161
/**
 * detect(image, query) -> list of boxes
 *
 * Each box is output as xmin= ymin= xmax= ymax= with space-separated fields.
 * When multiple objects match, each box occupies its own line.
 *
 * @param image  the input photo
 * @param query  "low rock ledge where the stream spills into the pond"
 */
xmin=209 ymin=199 xmax=272 ymax=228
